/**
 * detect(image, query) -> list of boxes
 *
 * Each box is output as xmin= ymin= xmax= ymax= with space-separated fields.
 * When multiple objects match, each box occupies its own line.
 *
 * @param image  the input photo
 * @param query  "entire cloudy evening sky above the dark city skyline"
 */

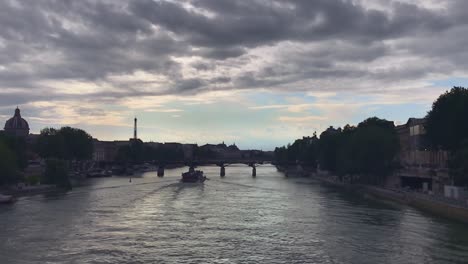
xmin=0 ymin=0 xmax=468 ymax=150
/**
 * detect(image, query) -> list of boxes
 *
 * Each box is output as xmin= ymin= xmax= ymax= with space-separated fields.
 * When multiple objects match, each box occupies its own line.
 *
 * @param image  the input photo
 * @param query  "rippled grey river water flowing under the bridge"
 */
xmin=0 ymin=165 xmax=468 ymax=264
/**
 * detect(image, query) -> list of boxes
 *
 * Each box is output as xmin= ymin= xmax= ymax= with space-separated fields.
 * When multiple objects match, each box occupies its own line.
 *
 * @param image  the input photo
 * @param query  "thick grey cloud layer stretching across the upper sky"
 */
xmin=0 ymin=0 xmax=468 ymax=105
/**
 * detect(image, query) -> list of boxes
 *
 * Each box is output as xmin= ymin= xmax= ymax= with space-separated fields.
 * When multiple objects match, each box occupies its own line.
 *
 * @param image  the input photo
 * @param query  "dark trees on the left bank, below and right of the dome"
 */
xmin=0 ymin=127 xmax=93 ymax=187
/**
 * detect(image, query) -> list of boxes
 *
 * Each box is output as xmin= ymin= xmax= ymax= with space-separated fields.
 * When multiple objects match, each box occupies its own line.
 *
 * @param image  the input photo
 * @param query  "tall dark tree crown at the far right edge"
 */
xmin=426 ymin=87 xmax=468 ymax=151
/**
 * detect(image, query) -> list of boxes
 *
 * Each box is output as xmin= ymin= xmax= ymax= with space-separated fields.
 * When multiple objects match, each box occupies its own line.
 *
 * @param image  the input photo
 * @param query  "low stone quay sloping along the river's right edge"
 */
xmin=278 ymin=168 xmax=468 ymax=223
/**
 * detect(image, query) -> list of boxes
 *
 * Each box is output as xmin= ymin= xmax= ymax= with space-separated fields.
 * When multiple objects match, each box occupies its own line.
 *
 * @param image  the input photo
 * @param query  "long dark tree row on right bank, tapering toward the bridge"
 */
xmin=275 ymin=117 xmax=399 ymax=184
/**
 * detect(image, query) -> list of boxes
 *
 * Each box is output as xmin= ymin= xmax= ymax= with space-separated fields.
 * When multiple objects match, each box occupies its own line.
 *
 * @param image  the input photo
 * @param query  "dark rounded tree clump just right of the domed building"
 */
xmin=36 ymin=127 xmax=93 ymax=160
